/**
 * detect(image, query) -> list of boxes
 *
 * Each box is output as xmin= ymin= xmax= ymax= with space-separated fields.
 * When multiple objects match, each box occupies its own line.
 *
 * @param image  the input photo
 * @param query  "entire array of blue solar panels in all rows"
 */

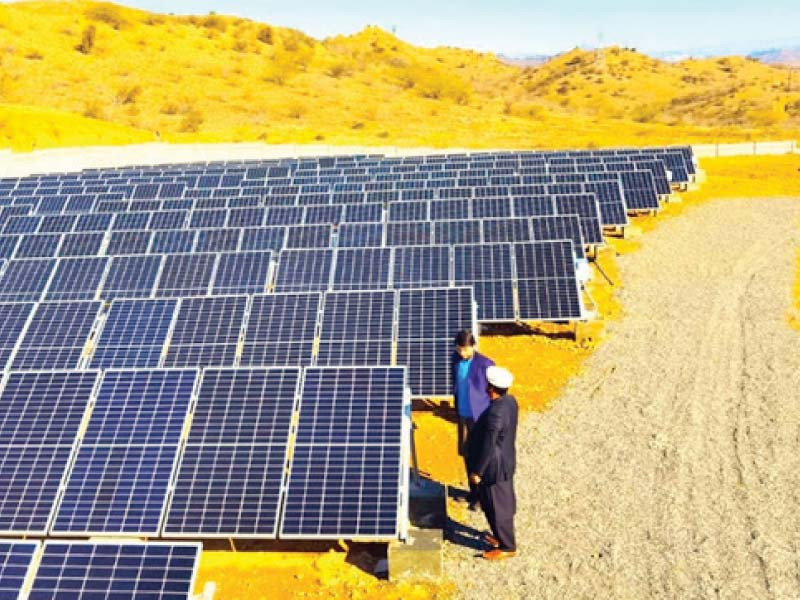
xmin=0 ymin=147 xmax=695 ymax=556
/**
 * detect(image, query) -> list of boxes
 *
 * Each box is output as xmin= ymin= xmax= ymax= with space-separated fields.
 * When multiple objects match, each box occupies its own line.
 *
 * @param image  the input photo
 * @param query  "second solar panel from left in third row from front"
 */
xmin=12 ymin=302 xmax=101 ymax=371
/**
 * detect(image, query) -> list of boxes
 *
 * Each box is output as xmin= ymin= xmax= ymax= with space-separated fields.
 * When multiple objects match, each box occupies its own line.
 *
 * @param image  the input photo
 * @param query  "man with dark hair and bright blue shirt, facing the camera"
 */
xmin=450 ymin=329 xmax=494 ymax=510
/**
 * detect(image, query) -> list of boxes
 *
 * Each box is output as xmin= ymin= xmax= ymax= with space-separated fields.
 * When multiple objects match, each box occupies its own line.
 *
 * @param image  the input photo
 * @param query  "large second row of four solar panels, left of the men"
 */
xmin=0 ymin=367 xmax=410 ymax=539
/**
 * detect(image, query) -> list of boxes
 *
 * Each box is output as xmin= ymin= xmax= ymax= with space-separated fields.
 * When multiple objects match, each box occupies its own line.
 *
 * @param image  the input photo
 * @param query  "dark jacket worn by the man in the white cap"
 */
xmin=467 ymin=394 xmax=517 ymax=485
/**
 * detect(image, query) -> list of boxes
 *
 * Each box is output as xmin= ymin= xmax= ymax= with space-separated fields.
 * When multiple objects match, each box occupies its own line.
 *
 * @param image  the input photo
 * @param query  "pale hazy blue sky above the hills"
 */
xmin=15 ymin=0 xmax=800 ymax=55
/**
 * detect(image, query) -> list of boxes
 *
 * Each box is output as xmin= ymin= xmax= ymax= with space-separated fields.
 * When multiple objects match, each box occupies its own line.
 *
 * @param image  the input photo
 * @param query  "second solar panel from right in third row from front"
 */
xmin=317 ymin=291 xmax=395 ymax=366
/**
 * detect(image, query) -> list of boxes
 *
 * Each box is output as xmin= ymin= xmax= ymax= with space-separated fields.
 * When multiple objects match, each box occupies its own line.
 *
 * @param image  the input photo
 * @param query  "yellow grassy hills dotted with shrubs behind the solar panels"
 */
xmin=0 ymin=1 xmax=800 ymax=149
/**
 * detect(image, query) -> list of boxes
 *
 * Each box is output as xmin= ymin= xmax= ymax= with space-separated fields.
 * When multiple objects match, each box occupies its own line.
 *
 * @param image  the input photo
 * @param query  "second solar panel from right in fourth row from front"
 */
xmin=454 ymin=244 xmax=515 ymax=321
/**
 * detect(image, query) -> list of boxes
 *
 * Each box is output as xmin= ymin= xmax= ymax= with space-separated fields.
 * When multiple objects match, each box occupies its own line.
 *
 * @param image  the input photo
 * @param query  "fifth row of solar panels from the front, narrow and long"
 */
xmin=0 ymin=215 xmax=602 ymax=266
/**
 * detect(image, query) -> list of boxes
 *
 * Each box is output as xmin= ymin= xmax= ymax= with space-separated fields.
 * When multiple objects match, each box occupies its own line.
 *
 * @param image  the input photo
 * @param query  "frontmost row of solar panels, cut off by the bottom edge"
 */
xmin=0 ymin=539 xmax=202 ymax=600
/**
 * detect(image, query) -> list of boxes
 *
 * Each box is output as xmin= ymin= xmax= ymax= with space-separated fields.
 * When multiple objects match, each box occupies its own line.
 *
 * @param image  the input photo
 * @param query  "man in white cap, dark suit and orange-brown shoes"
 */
xmin=468 ymin=366 xmax=517 ymax=560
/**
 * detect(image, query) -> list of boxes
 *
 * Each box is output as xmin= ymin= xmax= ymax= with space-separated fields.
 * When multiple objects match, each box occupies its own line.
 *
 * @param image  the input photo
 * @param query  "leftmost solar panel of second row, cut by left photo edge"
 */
xmin=0 ymin=371 xmax=98 ymax=534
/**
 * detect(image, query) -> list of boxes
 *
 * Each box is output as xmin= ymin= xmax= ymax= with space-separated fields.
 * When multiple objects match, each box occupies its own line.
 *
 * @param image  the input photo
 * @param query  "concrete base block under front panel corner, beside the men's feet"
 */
xmin=387 ymin=528 xmax=443 ymax=582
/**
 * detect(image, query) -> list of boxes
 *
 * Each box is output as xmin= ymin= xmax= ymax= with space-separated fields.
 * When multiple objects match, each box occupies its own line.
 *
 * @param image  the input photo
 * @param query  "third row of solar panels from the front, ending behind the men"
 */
xmin=0 ymin=287 xmax=476 ymax=397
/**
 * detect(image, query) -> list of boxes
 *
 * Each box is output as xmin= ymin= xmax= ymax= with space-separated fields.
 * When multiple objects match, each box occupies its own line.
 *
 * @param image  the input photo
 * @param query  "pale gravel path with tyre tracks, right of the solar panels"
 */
xmin=445 ymin=199 xmax=800 ymax=600
